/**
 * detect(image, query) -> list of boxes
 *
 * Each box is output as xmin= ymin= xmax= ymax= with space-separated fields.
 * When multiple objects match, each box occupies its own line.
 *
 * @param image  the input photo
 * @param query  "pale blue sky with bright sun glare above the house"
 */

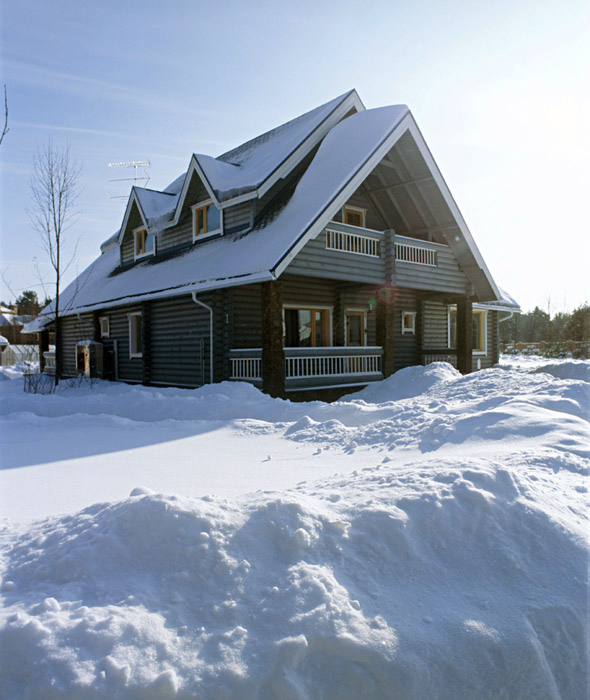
xmin=0 ymin=0 xmax=590 ymax=313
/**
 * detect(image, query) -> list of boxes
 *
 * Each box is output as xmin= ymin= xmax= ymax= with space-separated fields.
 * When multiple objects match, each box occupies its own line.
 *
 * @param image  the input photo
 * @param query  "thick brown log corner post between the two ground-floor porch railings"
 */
xmin=261 ymin=281 xmax=285 ymax=397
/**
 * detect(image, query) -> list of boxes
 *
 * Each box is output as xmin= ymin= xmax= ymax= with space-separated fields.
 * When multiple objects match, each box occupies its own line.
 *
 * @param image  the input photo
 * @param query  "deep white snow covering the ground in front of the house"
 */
xmin=0 ymin=357 xmax=590 ymax=700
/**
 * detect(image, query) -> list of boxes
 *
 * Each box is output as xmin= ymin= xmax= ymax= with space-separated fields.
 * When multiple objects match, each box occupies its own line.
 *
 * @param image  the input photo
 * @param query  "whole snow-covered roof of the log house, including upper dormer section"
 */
xmin=31 ymin=91 xmax=502 ymax=332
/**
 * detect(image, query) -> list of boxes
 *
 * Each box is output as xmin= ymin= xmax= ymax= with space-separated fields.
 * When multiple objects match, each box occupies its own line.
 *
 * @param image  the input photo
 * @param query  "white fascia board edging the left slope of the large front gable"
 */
xmin=272 ymin=111 xmax=413 ymax=277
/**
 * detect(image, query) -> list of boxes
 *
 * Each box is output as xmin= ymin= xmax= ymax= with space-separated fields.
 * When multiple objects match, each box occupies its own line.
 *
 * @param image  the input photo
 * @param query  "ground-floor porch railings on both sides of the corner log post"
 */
xmin=230 ymin=347 xmax=383 ymax=391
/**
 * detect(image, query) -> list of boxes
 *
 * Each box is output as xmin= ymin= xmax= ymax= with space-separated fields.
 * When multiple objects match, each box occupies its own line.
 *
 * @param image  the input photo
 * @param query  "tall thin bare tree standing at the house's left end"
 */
xmin=28 ymin=139 xmax=82 ymax=384
